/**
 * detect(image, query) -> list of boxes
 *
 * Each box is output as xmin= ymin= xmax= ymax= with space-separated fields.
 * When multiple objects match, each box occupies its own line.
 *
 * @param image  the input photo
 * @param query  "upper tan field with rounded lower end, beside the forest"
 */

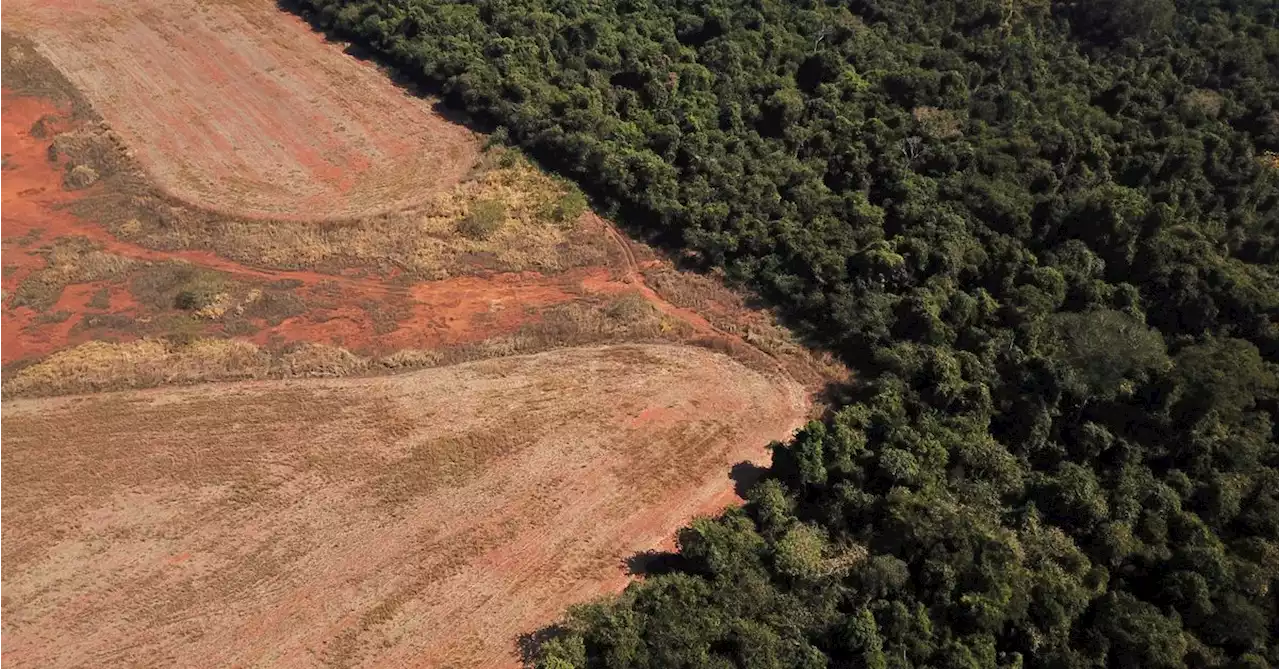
xmin=0 ymin=0 xmax=479 ymax=220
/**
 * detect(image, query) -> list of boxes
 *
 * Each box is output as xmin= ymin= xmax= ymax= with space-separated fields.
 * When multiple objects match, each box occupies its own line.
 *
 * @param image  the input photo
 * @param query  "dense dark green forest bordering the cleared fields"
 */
xmin=288 ymin=0 xmax=1280 ymax=669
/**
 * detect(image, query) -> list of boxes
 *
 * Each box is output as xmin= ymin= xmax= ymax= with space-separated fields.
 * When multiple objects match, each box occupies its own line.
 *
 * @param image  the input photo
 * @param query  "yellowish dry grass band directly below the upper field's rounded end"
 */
xmin=66 ymin=132 xmax=609 ymax=279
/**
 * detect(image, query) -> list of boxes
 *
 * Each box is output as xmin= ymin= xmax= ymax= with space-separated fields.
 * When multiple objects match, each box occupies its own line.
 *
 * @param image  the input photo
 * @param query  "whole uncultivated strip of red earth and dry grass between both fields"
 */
xmin=0 ymin=72 xmax=833 ymax=397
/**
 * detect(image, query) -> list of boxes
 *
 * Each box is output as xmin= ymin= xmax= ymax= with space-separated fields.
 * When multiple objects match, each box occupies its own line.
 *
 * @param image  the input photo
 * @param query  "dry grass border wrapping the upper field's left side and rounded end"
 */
xmin=0 ymin=34 xmax=609 ymax=279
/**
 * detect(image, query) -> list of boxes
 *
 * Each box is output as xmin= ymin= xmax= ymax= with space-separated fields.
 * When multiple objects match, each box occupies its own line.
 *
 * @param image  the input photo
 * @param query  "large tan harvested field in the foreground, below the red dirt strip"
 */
xmin=0 ymin=344 xmax=806 ymax=668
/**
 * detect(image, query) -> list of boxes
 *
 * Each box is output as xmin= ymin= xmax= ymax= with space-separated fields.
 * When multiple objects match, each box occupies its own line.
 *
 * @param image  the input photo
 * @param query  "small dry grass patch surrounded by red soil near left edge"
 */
xmin=13 ymin=237 xmax=133 ymax=311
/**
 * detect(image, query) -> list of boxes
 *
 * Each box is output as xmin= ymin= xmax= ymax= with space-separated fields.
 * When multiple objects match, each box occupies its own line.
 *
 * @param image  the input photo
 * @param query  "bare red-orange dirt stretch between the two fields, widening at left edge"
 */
xmin=0 ymin=83 xmax=614 ymax=365
